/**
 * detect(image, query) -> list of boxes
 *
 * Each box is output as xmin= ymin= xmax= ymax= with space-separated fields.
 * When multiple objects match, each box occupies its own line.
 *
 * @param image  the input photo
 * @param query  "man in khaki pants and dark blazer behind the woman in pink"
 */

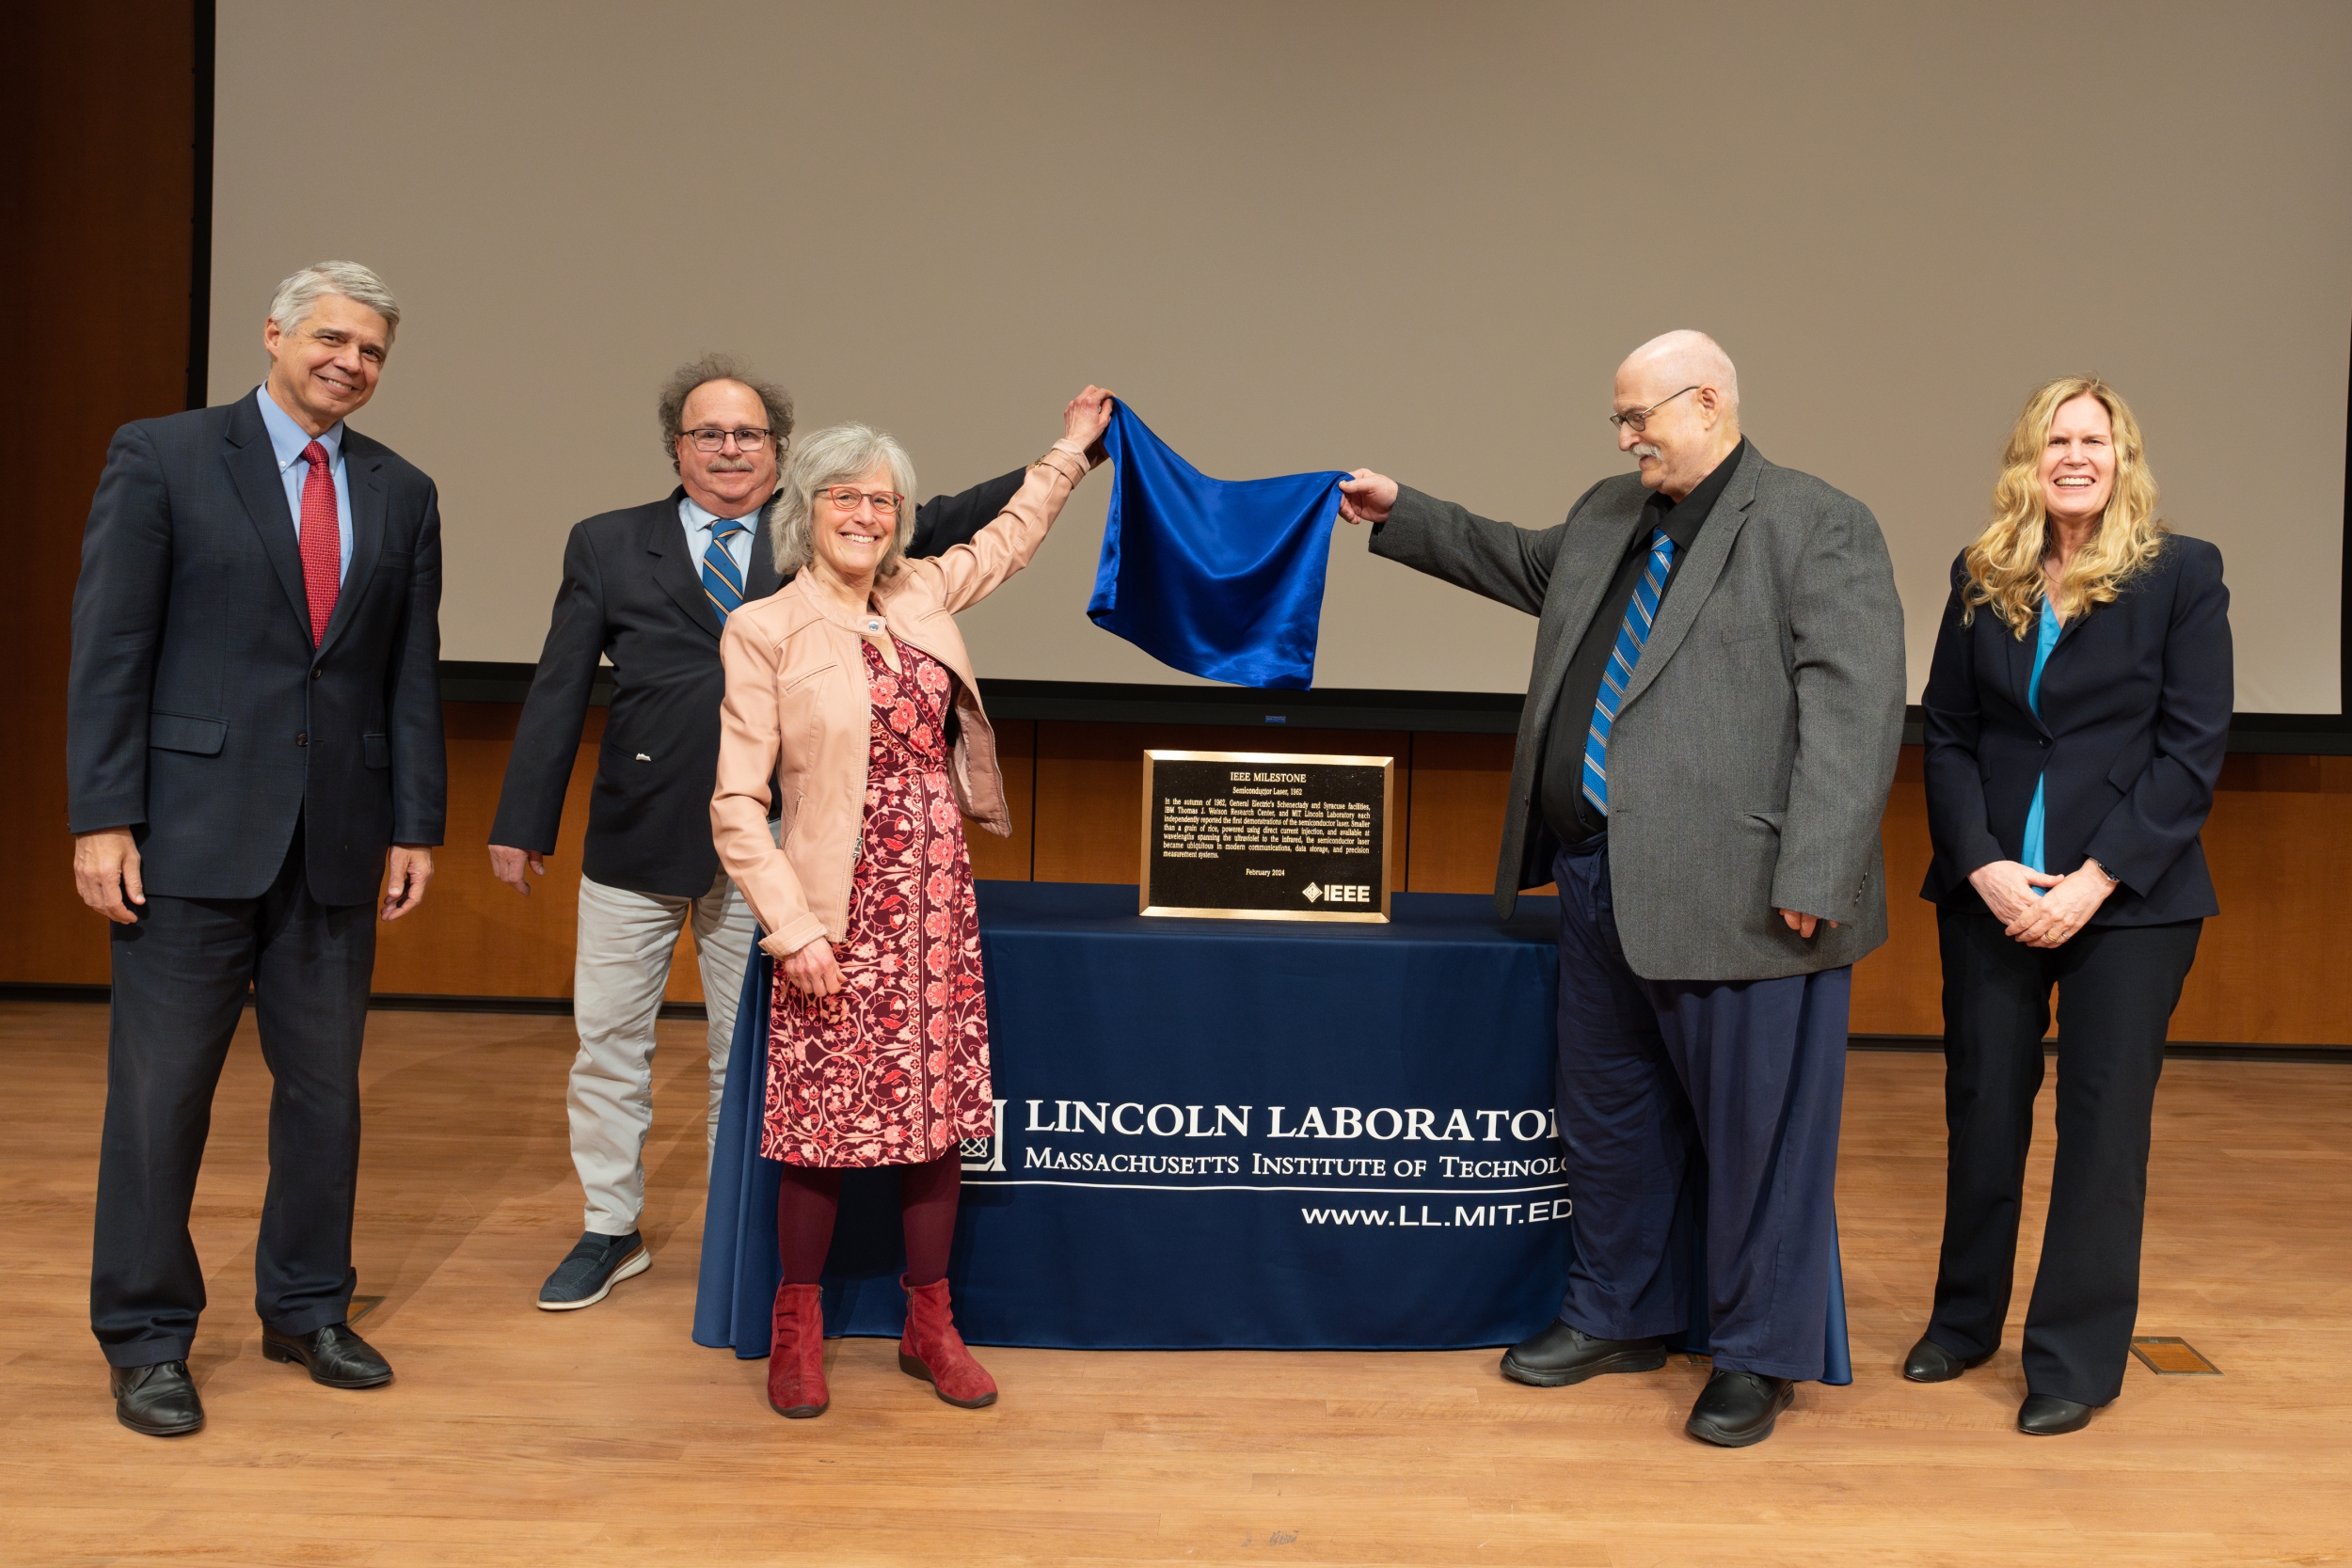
xmin=489 ymin=355 xmax=1025 ymax=1312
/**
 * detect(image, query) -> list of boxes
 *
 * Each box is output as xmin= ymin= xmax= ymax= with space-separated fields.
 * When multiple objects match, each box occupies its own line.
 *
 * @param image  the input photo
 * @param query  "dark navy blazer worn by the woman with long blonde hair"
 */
xmin=1919 ymin=533 xmax=2234 ymax=927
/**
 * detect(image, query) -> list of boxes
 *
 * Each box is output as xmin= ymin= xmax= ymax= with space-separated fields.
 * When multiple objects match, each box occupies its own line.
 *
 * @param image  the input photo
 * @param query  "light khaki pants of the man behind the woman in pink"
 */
xmin=567 ymin=875 xmax=753 ymax=1237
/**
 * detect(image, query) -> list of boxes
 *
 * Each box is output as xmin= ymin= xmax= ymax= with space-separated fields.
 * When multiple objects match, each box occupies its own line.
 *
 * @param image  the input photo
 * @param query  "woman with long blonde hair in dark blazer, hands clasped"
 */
xmin=1903 ymin=376 xmax=2233 ymax=1436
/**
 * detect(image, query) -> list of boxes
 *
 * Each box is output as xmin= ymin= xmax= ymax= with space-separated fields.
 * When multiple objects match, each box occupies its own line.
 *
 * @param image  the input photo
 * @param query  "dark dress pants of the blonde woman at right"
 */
xmin=1927 ymin=910 xmax=2204 ymax=1406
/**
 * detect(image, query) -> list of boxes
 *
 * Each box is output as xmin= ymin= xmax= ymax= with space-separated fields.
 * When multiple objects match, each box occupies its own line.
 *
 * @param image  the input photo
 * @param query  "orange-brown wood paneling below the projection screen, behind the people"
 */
xmin=275 ymin=703 xmax=2352 ymax=1046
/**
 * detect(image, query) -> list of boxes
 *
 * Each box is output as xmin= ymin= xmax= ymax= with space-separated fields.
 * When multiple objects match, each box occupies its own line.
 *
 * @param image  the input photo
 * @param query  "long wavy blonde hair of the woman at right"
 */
xmin=1960 ymin=376 xmax=2164 ymax=640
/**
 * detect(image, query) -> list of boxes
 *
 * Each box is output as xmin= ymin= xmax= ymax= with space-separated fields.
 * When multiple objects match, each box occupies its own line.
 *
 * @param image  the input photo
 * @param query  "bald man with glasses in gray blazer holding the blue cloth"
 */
xmin=1341 ymin=331 xmax=1903 ymax=1449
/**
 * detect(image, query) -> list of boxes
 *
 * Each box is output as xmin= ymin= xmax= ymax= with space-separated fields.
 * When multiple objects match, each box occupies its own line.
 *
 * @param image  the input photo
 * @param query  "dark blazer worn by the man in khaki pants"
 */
xmin=489 ymin=470 xmax=1025 ymax=898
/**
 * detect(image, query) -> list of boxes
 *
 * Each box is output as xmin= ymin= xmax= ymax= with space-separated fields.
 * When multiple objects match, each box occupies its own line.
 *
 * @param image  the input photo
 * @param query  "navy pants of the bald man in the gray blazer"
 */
xmin=1552 ymin=834 xmax=1853 ymax=1380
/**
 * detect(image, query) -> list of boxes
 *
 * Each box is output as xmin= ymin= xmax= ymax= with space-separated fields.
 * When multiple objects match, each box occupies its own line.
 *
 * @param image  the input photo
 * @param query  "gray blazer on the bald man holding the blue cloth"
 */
xmin=1372 ymin=442 xmax=1903 ymax=980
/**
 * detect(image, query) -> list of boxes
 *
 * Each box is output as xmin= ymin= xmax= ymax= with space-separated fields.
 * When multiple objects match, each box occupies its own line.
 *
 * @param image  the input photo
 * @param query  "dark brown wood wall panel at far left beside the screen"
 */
xmin=0 ymin=0 xmax=196 ymax=983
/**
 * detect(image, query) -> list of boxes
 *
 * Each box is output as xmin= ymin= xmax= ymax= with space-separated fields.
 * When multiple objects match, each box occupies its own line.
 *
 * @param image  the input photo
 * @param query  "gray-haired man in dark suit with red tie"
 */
xmin=66 ymin=261 xmax=447 ymax=1436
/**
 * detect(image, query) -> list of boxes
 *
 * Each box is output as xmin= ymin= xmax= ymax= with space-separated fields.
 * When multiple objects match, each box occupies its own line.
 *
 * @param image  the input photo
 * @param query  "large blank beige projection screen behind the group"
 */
xmin=210 ymin=0 xmax=2352 ymax=715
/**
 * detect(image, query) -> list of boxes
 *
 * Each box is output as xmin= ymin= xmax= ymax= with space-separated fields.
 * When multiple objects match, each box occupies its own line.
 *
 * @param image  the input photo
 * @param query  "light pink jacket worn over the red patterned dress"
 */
xmin=710 ymin=442 xmax=1087 ymax=959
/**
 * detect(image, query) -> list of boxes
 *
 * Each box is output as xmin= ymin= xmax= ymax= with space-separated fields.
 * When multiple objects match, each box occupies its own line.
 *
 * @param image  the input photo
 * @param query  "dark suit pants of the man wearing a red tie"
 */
xmin=89 ymin=828 xmax=376 ymax=1366
